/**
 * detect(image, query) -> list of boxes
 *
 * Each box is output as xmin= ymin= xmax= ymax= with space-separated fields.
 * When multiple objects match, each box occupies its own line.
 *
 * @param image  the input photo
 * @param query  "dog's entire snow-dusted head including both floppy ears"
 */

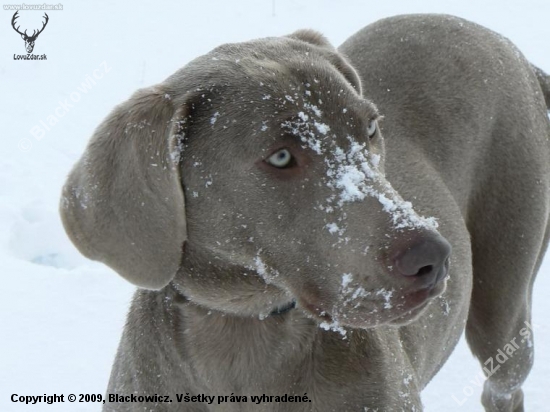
xmin=61 ymin=31 xmax=450 ymax=327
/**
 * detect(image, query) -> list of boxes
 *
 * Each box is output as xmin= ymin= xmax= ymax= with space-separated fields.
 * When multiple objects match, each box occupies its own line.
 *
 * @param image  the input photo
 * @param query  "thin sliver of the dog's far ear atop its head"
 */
xmin=287 ymin=29 xmax=362 ymax=95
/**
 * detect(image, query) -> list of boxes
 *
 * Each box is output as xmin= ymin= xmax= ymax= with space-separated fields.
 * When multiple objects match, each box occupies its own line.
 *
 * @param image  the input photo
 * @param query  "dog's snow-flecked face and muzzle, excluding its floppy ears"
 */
xmin=175 ymin=30 xmax=450 ymax=330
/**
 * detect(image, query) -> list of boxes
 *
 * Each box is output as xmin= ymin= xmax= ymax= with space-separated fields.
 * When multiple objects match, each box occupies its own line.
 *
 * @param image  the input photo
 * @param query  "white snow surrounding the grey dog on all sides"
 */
xmin=0 ymin=0 xmax=550 ymax=412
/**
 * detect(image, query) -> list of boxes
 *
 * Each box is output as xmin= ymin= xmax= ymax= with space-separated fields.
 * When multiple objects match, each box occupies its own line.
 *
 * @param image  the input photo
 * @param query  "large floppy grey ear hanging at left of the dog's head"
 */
xmin=60 ymin=86 xmax=187 ymax=289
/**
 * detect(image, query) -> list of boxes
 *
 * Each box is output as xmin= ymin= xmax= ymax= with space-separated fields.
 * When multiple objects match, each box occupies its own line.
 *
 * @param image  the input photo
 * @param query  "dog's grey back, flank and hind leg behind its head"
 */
xmin=339 ymin=15 xmax=550 ymax=411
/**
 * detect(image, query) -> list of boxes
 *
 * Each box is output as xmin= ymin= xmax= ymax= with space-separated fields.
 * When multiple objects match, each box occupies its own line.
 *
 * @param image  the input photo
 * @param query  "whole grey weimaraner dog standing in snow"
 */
xmin=61 ymin=15 xmax=550 ymax=412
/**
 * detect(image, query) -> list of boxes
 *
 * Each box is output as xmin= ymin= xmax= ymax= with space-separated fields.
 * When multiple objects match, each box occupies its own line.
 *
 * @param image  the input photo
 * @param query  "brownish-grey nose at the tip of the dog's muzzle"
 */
xmin=395 ymin=235 xmax=451 ymax=286
